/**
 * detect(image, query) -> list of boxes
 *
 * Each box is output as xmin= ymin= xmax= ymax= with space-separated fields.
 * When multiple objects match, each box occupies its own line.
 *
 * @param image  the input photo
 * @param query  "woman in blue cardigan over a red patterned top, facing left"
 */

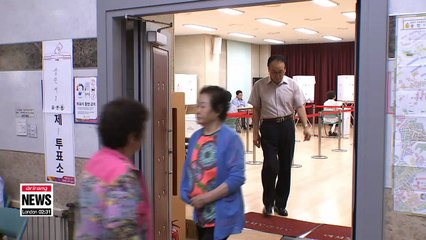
xmin=180 ymin=86 xmax=245 ymax=240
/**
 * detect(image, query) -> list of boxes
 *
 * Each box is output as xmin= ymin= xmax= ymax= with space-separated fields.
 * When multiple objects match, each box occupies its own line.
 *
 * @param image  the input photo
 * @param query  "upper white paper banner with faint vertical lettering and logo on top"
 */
xmin=43 ymin=39 xmax=73 ymax=113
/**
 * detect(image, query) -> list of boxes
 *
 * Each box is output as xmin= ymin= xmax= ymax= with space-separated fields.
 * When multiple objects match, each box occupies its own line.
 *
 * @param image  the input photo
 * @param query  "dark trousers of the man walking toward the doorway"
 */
xmin=260 ymin=119 xmax=295 ymax=208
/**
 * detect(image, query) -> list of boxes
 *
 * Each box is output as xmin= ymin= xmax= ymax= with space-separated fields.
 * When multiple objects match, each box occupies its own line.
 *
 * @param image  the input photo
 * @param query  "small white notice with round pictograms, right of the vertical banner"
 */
xmin=74 ymin=77 xmax=98 ymax=123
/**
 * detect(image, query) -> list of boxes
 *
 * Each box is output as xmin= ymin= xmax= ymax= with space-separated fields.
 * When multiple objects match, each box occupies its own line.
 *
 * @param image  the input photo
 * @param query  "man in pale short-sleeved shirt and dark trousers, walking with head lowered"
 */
xmin=248 ymin=55 xmax=311 ymax=216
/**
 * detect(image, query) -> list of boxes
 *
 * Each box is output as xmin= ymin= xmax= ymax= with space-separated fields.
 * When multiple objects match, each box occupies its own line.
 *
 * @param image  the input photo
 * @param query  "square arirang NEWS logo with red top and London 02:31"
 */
xmin=20 ymin=183 xmax=53 ymax=217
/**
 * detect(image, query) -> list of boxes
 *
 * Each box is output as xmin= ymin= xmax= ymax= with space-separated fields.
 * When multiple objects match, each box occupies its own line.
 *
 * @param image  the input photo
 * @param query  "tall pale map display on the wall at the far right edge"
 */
xmin=393 ymin=15 xmax=426 ymax=214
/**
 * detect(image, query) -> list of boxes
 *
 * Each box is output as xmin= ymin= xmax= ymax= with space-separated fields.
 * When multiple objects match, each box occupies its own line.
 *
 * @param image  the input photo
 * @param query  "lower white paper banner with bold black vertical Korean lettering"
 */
xmin=44 ymin=113 xmax=75 ymax=185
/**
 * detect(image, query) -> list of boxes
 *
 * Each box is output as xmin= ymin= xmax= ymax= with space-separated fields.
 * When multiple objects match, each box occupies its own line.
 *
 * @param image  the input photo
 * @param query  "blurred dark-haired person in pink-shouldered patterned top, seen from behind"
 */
xmin=76 ymin=99 xmax=152 ymax=240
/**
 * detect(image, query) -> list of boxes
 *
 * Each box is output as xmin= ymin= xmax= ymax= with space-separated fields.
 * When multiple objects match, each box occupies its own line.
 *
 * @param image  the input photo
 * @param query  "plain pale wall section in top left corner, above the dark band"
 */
xmin=0 ymin=0 xmax=97 ymax=44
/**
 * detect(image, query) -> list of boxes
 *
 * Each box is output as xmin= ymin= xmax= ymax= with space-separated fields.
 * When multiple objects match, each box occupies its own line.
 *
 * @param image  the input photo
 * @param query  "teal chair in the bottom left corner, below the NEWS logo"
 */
xmin=0 ymin=208 xmax=28 ymax=240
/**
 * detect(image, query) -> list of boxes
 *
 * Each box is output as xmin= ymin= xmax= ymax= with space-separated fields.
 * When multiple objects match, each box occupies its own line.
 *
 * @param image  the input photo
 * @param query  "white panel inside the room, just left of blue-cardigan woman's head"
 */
xmin=174 ymin=74 xmax=198 ymax=105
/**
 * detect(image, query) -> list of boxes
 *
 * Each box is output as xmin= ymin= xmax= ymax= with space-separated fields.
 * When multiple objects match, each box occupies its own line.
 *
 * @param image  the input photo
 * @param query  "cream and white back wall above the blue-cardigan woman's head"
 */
xmin=174 ymin=35 xmax=271 ymax=100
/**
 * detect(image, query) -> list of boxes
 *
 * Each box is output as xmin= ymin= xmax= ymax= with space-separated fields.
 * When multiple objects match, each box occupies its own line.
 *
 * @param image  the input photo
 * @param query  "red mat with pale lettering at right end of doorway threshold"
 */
xmin=306 ymin=224 xmax=352 ymax=240
